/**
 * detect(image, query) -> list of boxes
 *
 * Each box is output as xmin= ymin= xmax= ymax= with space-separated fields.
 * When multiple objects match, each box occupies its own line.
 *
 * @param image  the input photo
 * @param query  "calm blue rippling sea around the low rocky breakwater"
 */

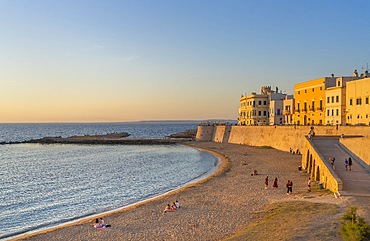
xmin=0 ymin=121 xmax=219 ymax=240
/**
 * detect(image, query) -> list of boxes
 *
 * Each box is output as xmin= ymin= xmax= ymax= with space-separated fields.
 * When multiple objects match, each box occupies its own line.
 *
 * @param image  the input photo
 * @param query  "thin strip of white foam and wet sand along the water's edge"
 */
xmin=7 ymin=143 xmax=228 ymax=241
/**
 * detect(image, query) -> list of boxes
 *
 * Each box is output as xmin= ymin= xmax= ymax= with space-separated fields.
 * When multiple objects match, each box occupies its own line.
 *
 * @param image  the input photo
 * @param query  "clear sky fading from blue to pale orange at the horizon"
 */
xmin=0 ymin=0 xmax=370 ymax=122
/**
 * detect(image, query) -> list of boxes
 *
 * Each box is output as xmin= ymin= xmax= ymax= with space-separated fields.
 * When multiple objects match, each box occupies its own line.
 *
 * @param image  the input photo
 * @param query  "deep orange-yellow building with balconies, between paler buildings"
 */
xmin=293 ymin=77 xmax=336 ymax=125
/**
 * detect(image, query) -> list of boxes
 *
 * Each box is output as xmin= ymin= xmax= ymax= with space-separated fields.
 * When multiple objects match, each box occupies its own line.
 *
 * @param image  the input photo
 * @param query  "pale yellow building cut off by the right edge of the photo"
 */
xmin=346 ymin=78 xmax=370 ymax=125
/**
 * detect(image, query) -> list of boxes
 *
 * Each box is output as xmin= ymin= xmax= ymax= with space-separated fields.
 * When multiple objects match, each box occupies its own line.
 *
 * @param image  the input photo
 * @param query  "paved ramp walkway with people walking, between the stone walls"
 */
xmin=312 ymin=137 xmax=370 ymax=221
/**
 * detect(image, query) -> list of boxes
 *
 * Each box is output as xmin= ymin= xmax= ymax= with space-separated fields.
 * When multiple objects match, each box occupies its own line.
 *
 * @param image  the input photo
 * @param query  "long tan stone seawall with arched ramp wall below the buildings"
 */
xmin=196 ymin=126 xmax=370 ymax=193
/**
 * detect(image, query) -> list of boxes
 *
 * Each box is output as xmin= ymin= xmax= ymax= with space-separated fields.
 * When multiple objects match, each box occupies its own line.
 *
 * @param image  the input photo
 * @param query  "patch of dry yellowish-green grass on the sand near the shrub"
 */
xmin=224 ymin=201 xmax=340 ymax=241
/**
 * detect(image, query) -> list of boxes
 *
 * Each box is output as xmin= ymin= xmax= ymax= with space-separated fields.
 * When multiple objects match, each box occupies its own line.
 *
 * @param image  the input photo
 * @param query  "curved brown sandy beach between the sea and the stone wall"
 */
xmin=15 ymin=142 xmax=344 ymax=241
